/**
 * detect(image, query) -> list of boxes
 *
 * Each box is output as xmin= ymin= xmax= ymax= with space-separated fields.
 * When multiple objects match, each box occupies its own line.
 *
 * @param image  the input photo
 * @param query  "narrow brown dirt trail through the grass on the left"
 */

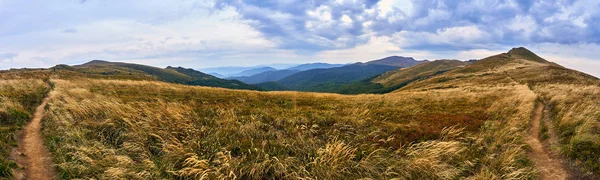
xmin=13 ymin=97 xmax=58 ymax=179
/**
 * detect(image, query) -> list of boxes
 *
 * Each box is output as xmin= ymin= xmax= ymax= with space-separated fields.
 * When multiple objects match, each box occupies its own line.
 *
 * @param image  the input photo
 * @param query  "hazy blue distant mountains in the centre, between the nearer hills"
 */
xmin=230 ymin=56 xmax=428 ymax=92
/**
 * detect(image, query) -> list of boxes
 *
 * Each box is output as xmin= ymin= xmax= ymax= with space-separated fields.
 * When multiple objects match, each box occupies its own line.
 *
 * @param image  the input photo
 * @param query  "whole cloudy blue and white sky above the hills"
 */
xmin=0 ymin=0 xmax=600 ymax=77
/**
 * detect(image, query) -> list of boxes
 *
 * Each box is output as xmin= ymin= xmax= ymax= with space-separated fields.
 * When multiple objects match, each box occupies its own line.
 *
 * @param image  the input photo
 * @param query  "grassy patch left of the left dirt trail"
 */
xmin=0 ymin=69 xmax=49 ymax=179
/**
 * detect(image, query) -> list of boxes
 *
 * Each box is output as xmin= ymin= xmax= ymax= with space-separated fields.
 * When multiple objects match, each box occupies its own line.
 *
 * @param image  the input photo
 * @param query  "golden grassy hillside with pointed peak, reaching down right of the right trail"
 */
xmin=399 ymin=48 xmax=600 ymax=175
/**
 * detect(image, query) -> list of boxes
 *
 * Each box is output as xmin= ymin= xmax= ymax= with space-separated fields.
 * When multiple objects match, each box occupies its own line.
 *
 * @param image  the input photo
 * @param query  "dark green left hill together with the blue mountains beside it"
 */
xmin=73 ymin=56 xmax=429 ymax=93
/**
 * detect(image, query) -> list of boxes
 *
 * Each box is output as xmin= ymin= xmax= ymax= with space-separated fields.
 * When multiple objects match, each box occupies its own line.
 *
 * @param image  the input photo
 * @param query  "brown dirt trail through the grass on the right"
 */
xmin=526 ymin=102 xmax=569 ymax=180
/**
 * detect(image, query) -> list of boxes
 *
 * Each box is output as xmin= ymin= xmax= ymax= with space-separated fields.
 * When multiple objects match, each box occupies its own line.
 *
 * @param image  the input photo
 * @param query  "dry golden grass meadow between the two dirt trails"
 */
xmin=44 ymin=78 xmax=536 ymax=179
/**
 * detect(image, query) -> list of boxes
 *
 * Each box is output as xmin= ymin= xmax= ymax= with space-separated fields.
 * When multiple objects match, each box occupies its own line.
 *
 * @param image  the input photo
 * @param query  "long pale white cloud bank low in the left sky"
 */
xmin=0 ymin=4 xmax=276 ymax=68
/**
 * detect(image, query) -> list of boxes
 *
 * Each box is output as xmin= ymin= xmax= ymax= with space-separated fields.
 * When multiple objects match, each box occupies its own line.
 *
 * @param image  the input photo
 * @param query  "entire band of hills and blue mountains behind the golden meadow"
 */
xmin=50 ymin=48 xmax=596 ymax=94
